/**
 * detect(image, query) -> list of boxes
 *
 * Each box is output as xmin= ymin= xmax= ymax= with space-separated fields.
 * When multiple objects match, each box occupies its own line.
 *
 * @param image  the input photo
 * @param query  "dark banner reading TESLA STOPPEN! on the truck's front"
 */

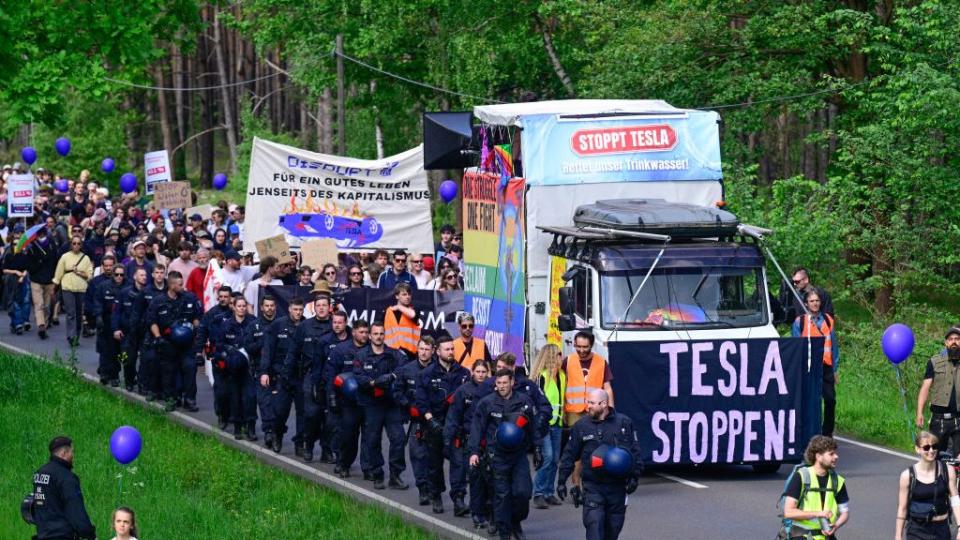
xmin=608 ymin=338 xmax=823 ymax=464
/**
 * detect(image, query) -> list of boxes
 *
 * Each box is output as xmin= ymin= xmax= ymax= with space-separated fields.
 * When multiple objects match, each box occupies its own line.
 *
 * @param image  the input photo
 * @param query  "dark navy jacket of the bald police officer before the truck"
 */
xmin=557 ymin=407 xmax=643 ymax=484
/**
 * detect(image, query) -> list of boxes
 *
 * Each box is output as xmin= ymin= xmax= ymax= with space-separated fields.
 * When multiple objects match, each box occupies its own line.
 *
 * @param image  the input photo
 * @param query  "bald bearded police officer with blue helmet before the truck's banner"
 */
xmin=557 ymin=388 xmax=643 ymax=540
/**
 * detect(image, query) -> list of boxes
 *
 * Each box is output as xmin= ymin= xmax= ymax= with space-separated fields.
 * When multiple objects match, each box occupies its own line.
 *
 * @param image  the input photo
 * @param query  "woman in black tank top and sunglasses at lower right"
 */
xmin=895 ymin=431 xmax=960 ymax=540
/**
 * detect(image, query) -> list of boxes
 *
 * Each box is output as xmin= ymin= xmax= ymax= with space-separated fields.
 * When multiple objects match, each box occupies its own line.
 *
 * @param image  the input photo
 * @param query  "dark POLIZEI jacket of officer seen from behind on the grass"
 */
xmin=33 ymin=456 xmax=97 ymax=539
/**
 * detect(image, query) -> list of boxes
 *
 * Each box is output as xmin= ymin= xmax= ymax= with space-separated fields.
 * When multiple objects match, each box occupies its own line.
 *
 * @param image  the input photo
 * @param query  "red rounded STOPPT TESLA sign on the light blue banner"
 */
xmin=570 ymin=124 xmax=677 ymax=156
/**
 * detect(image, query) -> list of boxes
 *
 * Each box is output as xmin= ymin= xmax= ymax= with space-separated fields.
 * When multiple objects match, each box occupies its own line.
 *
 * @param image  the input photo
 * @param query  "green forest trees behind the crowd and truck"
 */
xmin=0 ymin=0 xmax=960 ymax=315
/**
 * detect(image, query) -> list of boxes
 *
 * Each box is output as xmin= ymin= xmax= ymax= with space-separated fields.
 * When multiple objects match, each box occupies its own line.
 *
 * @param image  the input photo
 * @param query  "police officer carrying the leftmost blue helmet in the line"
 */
xmin=146 ymin=270 xmax=201 ymax=412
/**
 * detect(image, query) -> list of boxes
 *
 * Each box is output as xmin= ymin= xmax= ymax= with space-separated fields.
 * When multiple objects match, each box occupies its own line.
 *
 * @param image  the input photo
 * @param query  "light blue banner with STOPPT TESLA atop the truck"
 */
xmin=523 ymin=111 xmax=722 ymax=185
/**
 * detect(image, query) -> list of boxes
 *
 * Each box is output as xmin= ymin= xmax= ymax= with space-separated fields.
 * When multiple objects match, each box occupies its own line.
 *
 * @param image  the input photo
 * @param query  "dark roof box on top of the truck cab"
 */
xmin=573 ymin=199 xmax=740 ymax=238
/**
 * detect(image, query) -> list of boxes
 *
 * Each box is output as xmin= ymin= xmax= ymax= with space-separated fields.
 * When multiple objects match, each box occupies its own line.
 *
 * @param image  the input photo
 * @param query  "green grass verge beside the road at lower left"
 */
xmin=0 ymin=353 xmax=430 ymax=539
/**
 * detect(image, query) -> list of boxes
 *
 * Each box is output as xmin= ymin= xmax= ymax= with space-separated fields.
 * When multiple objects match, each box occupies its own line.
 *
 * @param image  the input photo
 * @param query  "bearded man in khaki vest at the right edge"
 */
xmin=917 ymin=324 xmax=960 ymax=455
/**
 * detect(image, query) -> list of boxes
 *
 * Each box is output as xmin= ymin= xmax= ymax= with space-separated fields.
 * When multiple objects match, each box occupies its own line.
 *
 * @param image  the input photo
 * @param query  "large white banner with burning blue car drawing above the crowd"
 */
xmin=242 ymin=135 xmax=433 ymax=253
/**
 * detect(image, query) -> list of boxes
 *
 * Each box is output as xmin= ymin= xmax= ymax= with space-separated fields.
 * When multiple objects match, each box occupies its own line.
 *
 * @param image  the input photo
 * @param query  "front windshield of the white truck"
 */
xmin=600 ymin=267 xmax=767 ymax=330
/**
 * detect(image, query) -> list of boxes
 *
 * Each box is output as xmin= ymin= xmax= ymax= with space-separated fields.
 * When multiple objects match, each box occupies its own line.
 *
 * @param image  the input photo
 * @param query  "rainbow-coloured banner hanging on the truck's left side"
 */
xmin=464 ymin=172 xmax=526 ymax=363
